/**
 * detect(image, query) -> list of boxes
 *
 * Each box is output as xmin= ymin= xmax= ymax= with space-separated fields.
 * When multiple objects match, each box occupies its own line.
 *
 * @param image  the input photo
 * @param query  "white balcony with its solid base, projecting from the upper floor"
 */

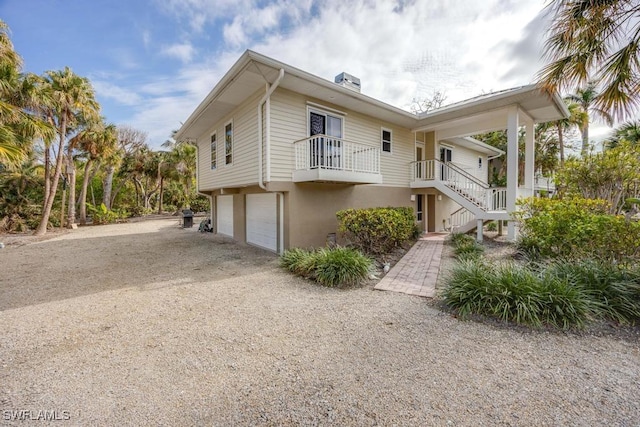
xmin=293 ymin=135 xmax=382 ymax=184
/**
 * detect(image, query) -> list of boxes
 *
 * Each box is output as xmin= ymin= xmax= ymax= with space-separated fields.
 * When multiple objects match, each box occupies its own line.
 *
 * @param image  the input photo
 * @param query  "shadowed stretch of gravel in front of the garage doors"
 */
xmin=0 ymin=221 xmax=277 ymax=311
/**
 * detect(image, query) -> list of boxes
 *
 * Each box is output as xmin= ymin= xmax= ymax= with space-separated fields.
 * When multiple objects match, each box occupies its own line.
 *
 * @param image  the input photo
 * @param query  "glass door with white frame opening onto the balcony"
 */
xmin=309 ymin=111 xmax=342 ymax=169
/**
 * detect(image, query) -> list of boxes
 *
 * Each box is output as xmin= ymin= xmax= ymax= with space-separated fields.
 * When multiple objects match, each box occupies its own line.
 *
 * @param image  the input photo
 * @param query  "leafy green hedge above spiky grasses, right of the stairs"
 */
xmin=517 ymin=198 xmax=640 ymax=264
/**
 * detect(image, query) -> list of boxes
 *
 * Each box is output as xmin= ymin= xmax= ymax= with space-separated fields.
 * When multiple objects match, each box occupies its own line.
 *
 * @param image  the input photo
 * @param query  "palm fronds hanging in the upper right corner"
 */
xmin=538 ymin=0 xmax=640 ymax=120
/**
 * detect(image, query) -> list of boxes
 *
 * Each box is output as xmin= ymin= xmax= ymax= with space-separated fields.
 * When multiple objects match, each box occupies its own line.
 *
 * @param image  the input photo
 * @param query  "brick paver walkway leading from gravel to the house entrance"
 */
xmin=375 ymin=234 xmax=446 ymax=298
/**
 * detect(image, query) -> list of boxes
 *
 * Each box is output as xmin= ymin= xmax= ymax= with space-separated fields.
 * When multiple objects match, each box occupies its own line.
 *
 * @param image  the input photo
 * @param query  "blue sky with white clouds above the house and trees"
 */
xmin=0 ymin=0 xmax=604 ymax=148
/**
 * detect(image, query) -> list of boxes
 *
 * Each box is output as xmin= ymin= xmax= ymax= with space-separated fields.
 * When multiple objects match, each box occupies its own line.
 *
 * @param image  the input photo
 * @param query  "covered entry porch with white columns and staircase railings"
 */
xmin=409 ymin=85 xmax=568 ymax=241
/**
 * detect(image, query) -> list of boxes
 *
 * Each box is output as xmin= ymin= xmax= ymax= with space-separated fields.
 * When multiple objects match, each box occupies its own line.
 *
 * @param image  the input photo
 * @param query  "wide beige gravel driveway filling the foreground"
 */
xmin=0 ymin=219 xmax=640 ymax=426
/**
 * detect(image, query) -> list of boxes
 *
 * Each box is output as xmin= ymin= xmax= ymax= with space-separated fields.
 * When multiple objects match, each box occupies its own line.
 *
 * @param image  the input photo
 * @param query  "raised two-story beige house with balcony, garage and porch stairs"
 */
xmin=176 ymin=51 xmax=567 ymax=252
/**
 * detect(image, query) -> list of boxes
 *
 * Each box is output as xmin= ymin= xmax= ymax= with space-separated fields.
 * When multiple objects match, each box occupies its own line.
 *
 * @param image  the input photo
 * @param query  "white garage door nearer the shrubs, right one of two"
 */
xmin=247 ymin=194 xmax=278 ymax=252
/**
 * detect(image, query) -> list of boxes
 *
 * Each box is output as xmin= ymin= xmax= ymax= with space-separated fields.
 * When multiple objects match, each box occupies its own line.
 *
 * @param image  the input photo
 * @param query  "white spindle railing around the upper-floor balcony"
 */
xmin=293 ymin=135 xmax=380 ymax=174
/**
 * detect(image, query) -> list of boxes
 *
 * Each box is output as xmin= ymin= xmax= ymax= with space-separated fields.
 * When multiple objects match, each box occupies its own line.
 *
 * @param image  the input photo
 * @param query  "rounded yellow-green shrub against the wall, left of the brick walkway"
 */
xmin=336 ymin=207 xmax=417 ymax=254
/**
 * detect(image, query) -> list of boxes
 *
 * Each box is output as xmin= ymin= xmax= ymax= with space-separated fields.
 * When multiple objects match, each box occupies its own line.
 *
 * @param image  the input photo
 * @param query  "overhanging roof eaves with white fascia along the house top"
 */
xmin=176 ymin=50 xmax=568 ymax=140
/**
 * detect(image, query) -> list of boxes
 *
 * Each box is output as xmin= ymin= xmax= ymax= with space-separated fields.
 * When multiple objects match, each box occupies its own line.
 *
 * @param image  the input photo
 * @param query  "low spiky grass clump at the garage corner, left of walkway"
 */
xmin=280 ymin=247 xmax=373 ymax=287
